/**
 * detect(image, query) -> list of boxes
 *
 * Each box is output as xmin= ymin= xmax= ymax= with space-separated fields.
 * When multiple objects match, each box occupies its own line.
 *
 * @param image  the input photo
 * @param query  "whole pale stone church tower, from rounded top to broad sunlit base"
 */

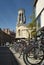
xmin=16 ymin=9 xmax=28 ymax=38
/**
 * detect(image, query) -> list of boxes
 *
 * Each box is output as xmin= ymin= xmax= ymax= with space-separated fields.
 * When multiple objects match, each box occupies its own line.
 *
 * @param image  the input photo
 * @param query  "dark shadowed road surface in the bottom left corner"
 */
xmin=0 ymin=47 xmax=20 ymax=65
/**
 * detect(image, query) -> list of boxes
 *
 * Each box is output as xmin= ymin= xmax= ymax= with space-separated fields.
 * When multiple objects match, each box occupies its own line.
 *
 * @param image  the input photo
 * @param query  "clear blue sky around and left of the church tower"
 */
xmin=0 ymin=0 xmax=34 ymax=30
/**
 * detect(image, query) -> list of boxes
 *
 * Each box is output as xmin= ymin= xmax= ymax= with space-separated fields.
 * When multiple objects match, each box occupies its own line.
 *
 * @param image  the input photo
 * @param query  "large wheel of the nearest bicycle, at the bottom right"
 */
xmin=26 ymin=47 xmax=43 ymax=65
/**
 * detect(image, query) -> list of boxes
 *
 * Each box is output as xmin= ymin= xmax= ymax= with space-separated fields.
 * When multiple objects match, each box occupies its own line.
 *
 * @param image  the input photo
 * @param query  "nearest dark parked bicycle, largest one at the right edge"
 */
xmin=23 ymin=27 xmax=44 ymax=65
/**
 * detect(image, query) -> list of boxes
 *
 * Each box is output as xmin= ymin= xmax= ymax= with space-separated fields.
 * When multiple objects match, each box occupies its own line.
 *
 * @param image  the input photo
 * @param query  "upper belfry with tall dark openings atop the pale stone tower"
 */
xmin=17 ymin=9 xmax=26 ymax=25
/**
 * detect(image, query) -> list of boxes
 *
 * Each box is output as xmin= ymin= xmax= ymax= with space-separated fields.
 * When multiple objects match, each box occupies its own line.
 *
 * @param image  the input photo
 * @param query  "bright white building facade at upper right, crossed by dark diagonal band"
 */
xmin=34 ymin=0 xmax=44 ymax=30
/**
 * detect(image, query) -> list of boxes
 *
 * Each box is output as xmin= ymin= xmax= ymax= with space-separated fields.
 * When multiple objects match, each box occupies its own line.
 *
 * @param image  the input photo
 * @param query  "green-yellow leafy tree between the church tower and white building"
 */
xmin=27 ymin=11 xmax=36 ymax=37
